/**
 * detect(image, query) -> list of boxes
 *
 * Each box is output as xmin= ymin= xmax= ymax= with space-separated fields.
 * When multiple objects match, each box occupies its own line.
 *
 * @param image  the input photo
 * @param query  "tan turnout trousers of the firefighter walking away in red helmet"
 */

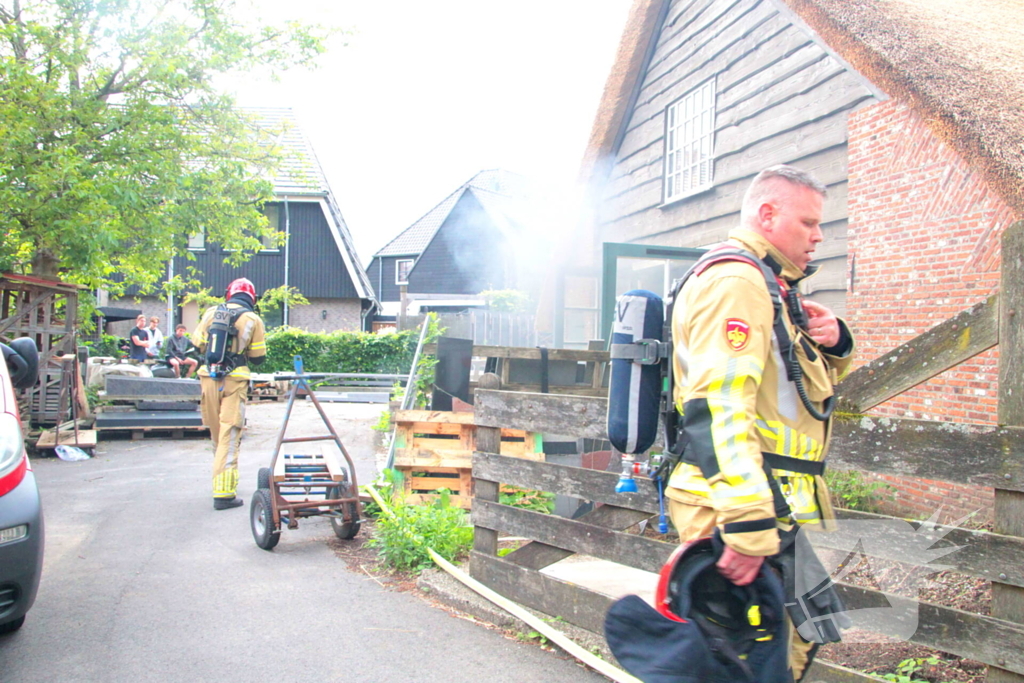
xmin=200 ymin=377 xmax=249 ymax=499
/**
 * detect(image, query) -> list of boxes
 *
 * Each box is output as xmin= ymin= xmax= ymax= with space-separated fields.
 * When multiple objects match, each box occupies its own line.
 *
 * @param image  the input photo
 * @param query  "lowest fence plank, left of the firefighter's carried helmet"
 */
xmin=469 ymin=552 xmax=612 ymax=633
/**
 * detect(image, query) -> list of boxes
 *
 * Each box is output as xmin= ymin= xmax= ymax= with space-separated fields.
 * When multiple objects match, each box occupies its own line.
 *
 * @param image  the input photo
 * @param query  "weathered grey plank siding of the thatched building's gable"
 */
xmin=600 ymin=0 xmax=877 ymax=312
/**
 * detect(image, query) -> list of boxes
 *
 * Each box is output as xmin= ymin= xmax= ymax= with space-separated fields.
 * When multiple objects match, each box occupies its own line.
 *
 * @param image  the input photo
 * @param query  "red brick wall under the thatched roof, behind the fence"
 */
xmin=847 ymin=100 xmax=1018 ymax=522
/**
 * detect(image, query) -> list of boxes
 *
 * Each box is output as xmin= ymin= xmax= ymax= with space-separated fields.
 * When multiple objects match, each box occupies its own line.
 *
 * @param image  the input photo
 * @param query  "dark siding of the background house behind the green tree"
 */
xmin=174 ymin=202 xmax=358 ymax=299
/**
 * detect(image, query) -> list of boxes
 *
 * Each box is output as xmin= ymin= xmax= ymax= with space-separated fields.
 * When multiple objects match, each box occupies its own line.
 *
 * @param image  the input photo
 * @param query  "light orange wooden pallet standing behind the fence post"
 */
xmin=392 ymin=411 xmax=544 ymax=510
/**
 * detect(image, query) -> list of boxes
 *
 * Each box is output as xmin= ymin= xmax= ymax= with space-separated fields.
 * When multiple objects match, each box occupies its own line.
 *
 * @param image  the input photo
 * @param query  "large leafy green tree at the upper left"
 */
xmin=0 ymin=0 xmax=326 ymax=296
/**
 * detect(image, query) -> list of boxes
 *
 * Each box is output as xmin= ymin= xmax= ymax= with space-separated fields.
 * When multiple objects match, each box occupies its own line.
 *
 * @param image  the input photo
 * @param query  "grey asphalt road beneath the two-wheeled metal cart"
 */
xmin=0 ymin=403 xmax=606 ymax=683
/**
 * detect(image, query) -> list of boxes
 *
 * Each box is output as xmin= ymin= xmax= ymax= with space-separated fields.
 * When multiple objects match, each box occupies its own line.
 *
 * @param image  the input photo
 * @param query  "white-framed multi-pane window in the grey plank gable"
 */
xmin=665 ymin=78 xmax=715 ymax=203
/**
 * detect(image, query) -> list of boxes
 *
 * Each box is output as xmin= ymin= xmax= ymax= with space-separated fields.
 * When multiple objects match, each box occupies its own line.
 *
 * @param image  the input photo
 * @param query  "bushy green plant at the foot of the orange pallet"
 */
xmin=367 ymin=488 xmax=473 ymax=571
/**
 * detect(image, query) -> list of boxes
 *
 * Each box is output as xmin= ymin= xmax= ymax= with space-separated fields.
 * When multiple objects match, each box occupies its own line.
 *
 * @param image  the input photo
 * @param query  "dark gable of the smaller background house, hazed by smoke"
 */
xmin=409 ymin=191 xmax=514 ymax=294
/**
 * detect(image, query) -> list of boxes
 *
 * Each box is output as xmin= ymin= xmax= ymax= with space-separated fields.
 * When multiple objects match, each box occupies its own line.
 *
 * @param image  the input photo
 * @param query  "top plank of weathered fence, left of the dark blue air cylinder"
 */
xmin=475 ymin=389 xmax=608 ymax=440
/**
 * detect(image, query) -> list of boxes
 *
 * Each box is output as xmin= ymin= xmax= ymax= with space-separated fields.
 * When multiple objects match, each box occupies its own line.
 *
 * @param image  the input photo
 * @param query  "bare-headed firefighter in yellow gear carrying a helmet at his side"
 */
xmin=666 ymin=166 xmax=854 ymax=681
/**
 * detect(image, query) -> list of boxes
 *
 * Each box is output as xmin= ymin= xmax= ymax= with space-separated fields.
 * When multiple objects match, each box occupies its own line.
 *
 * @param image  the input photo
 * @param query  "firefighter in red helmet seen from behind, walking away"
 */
xmin=191 ymin=278 xmax=266 ymax=510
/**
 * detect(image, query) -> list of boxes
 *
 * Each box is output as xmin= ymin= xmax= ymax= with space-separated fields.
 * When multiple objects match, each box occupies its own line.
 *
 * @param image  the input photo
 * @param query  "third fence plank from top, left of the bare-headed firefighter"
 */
xmin=473 ymin=501 xmax=677 ymax=572
